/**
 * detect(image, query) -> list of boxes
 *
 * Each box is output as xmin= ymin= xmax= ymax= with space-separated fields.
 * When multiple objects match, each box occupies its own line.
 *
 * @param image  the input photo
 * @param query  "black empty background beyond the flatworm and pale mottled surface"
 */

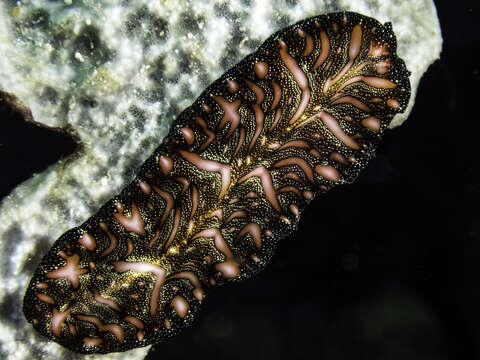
xmin=0 ymin=0 xmax=480 ymax=360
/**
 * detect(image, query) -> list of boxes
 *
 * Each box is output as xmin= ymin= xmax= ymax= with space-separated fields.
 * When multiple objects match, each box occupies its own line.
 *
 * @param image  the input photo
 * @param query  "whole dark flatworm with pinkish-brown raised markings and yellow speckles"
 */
xmin=24 ymin=12 xmax=410 ymax=353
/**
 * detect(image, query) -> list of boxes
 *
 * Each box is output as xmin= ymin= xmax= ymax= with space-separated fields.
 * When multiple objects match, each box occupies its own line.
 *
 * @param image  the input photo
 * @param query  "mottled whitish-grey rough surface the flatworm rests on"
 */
xmin=0 ymin=1 xmax=440 ymax=358
